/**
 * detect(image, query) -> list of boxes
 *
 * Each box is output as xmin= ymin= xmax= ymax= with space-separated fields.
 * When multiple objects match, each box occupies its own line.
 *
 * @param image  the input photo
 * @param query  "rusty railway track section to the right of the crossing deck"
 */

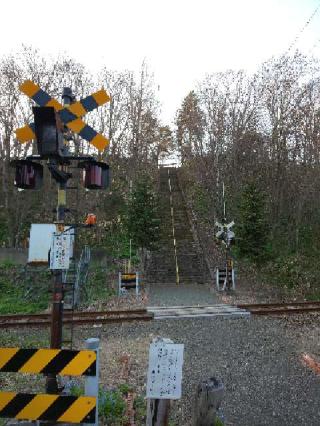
xmin=237 ymin=301 xmax=320 ymax=315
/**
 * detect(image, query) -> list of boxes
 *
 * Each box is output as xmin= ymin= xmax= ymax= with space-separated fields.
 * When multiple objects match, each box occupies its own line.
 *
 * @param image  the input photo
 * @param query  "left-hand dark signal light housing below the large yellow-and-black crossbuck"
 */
xmin=10 ymin=160 xmax=43 ymax=189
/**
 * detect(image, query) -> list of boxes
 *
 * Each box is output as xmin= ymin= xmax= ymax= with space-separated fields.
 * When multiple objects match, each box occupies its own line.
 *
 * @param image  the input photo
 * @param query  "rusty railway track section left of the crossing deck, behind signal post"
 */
xmin=0 ymin=309 xmax=153 ymax=328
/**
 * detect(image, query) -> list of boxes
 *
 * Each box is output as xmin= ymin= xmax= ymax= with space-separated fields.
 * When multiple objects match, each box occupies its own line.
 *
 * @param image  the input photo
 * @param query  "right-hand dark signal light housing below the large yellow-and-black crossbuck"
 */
xmin=78 ymin=161 xmax=110 ymax=189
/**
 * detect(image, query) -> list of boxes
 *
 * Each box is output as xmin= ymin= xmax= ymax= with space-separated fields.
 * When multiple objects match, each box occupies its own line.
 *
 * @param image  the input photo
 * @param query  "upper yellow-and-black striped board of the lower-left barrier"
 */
xmin=0 ymin=348 xmax=96 ymax=376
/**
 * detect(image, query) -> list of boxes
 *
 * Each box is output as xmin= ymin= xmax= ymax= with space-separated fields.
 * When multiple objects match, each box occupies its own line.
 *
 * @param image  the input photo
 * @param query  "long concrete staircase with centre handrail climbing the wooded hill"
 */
xmin=147 ymin=168 xmax=206 ymax=284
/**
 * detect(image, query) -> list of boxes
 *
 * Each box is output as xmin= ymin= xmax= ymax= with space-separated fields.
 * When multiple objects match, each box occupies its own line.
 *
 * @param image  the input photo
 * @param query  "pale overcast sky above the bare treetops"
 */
xmin=0 ymin=0 xmax=320 ymax=122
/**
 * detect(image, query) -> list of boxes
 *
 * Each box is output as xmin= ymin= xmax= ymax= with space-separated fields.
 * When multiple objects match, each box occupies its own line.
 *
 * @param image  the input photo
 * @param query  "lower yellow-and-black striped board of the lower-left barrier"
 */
xmin=0 ymin=392 xmax=96 ymax=423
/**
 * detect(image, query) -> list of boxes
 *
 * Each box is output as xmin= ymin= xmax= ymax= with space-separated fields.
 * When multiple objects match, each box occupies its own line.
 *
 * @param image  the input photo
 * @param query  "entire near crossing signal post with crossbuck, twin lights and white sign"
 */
xmin=11 ymin=80 xmax=110 ymax=394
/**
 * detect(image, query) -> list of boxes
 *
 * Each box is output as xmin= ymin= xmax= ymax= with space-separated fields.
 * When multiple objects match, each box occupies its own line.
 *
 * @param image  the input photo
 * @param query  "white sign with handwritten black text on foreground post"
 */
xmin=147 ymin=340 xmax=184 ymax=399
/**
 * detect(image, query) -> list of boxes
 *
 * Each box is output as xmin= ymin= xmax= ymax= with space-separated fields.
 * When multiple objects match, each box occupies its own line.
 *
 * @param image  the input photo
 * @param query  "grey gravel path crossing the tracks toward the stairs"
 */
xmin=72 ymin=286 xmax=320 ymax=426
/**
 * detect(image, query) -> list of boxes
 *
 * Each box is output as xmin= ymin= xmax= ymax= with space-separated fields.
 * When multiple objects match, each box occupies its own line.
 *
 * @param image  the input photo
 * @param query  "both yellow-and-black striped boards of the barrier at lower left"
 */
xmin=0 ymin=348 xmax=96 ymax=423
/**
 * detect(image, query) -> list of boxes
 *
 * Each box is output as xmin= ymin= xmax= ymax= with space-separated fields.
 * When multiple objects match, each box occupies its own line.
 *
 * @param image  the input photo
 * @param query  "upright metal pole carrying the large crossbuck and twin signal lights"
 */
xmin=46 ymin=88 xmax=72 ymax=394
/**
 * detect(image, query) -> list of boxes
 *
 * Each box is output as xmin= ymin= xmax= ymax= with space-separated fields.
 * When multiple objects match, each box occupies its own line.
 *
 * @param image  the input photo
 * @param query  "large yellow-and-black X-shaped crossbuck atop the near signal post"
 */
xmin=16 ymin=80 xmax=110 ymax=151
